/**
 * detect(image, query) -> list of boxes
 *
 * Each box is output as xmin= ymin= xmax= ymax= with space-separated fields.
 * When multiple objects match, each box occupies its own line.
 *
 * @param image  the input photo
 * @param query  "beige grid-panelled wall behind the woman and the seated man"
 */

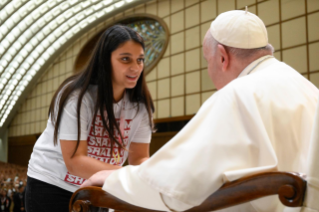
xmin=9 ymin=0 xmax=319 ymax=137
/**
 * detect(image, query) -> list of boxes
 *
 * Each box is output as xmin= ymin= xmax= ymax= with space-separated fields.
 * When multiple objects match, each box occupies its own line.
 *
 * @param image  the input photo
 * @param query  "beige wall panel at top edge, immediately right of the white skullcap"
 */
xmin=258 ymin=0 xmax=279 ymax=25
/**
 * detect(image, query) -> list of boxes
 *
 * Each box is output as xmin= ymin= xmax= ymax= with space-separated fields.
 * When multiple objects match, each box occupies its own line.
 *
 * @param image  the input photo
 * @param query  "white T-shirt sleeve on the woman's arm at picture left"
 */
xmin=58 ymin=95 xmax=91 ymax=140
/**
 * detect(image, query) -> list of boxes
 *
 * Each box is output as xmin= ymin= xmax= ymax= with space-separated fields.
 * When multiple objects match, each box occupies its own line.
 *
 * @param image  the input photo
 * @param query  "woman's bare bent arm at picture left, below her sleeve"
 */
xmin=60 ymin=140 xmax=121 ymax=179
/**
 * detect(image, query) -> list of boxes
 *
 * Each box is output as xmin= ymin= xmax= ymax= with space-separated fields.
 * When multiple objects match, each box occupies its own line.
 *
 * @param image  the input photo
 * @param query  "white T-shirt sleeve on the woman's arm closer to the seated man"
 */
xmin=132 ymin=106 xmax=152 ymax=143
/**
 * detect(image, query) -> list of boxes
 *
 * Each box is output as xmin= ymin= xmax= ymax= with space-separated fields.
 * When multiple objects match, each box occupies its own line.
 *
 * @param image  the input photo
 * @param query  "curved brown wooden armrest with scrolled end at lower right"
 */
xmin=186 ymin=172 xmax=307 ymax=212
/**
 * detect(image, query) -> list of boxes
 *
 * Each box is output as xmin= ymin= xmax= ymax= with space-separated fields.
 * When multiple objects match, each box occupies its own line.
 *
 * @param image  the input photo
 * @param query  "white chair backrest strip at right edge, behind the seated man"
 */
xmin=302 ymin=98 xmax=319 ymax=212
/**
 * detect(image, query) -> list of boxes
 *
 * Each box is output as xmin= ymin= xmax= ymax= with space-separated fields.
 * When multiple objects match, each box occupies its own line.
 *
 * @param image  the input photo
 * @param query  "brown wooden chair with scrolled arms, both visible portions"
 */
xmin=69 ymin=172 xmax=307 ymax=212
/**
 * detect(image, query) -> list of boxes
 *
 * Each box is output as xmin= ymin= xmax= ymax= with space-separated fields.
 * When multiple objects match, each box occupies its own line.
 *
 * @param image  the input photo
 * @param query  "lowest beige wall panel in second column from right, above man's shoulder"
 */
xmin=282 ymin=46 xmax=307 ymax=73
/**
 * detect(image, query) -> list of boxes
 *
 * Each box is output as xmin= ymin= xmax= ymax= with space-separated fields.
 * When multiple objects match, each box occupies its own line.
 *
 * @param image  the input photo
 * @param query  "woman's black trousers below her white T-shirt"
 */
xmin=25 ymin=177 xmax=108 ymax=212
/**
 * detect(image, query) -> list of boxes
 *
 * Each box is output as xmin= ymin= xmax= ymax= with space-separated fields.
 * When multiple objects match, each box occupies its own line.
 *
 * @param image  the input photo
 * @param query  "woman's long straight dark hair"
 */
xmin=49 ymin=25 xmax=154 ymax=157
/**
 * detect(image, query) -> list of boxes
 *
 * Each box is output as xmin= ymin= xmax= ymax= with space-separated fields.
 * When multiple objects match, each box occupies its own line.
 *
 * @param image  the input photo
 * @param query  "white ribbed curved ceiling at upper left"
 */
xmin=0 ymin=0 xmax=145 ymax=128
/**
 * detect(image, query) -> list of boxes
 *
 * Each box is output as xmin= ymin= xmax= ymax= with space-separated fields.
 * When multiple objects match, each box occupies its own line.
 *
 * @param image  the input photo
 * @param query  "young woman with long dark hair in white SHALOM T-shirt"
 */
xmin=26 ymin=25 xmax=154 ymax=212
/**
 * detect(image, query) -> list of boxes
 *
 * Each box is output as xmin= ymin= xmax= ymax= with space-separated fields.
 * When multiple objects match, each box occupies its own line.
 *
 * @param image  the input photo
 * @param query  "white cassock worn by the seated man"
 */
xmin=103 ymin=56 xmax=319 ymax=212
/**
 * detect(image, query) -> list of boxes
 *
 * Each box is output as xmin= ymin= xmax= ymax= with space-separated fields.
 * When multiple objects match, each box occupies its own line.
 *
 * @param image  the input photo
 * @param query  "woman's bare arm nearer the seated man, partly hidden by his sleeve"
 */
xmin=128 ymin=142 xmax=150 ymax=165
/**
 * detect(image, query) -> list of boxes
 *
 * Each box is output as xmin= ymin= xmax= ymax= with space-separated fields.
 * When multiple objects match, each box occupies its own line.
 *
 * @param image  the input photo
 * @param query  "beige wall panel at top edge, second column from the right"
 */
xmin=281 ymin=0 xmax=306 ymax=20
